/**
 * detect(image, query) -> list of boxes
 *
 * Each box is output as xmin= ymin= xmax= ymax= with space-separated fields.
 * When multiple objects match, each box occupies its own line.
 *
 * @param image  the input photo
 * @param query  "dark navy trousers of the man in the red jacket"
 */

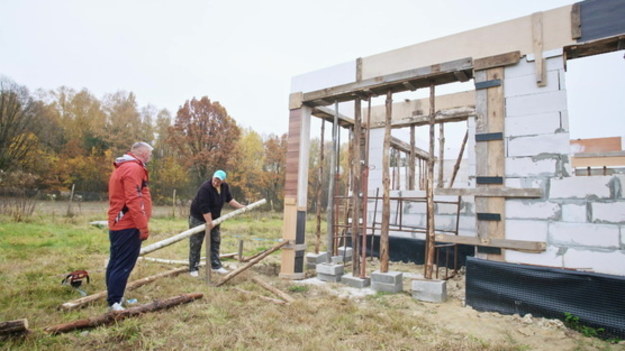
xmin=106 ymin=228 xmax=141 ymax=306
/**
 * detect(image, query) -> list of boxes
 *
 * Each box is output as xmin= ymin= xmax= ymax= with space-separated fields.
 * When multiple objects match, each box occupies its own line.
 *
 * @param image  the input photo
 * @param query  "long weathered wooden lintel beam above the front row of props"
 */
xmin=303 ymin=58 xmax=473 ymax=106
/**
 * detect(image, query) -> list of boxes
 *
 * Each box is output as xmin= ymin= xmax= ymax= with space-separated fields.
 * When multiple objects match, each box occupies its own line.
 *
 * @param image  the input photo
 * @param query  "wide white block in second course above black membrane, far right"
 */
xmin=549 ymin=222 xmax=620 ymax=249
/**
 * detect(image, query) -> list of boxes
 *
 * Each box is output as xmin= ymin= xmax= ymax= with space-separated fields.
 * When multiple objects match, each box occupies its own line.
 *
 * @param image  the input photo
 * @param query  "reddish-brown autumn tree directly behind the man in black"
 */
xmin=171 ymin=96 xmax=241 ymax=190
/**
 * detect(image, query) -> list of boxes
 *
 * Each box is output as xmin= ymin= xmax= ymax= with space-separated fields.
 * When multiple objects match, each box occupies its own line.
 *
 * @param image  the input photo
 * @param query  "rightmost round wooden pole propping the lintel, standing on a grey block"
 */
xmin=424 ymin=85 xmax=436 ymax=279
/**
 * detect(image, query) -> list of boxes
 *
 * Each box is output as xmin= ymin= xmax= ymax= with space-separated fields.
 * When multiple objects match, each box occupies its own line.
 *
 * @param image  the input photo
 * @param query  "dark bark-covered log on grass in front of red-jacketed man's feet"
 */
xmin=44 ymin=293 xmax=204 ymax=334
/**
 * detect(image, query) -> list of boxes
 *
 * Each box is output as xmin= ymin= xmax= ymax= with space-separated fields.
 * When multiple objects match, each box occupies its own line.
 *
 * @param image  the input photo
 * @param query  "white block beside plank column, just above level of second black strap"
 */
xmin=504 ymin=111 xmax=562 ymax=137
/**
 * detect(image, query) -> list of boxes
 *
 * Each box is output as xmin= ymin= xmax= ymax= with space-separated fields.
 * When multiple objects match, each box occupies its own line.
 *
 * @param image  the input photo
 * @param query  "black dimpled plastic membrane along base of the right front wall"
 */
xmin=466 ymin=257 xmax=625 ymax=338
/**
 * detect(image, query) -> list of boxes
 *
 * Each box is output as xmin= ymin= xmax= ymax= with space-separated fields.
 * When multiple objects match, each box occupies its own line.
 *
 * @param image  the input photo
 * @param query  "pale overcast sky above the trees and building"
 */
xmin=0 ymin=0 xmax=625 ymax=143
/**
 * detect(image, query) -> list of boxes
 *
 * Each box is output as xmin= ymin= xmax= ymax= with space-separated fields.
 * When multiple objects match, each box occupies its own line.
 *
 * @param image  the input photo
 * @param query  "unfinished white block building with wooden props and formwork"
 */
xmin=280 ymin=0 xmax=625 ymax=336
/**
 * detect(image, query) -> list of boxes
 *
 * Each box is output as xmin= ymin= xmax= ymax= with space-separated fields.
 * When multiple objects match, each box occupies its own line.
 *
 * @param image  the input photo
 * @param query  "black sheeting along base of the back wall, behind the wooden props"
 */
xmin=356 ymin=235 xmax=475 ymax=268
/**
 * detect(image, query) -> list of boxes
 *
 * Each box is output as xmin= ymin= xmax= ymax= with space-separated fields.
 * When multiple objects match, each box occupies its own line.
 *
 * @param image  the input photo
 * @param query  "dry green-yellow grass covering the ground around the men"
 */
xmin=0 ymin=204 xmax=619 ymax=350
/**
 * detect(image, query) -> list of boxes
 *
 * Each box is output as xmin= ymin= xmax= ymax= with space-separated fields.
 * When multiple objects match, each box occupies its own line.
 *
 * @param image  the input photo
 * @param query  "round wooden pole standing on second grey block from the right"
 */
xmin=380 ymin=90 xmax=393 ymax=273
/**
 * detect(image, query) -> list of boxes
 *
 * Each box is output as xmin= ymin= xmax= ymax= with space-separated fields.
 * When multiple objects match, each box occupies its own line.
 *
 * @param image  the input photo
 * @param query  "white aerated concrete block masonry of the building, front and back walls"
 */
xmin=368 ymin=52 xmax=625 ymax=276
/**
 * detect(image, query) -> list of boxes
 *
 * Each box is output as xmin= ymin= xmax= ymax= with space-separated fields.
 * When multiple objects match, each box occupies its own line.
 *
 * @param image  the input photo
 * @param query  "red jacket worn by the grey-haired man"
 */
xmin=108 ymin=153 xmax=152 ymax=233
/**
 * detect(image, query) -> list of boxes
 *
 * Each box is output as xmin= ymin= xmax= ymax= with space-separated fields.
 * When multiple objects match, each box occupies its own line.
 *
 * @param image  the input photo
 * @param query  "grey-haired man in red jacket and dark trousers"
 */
xmin=106 ymin=142 xmax=153 ymax=311
